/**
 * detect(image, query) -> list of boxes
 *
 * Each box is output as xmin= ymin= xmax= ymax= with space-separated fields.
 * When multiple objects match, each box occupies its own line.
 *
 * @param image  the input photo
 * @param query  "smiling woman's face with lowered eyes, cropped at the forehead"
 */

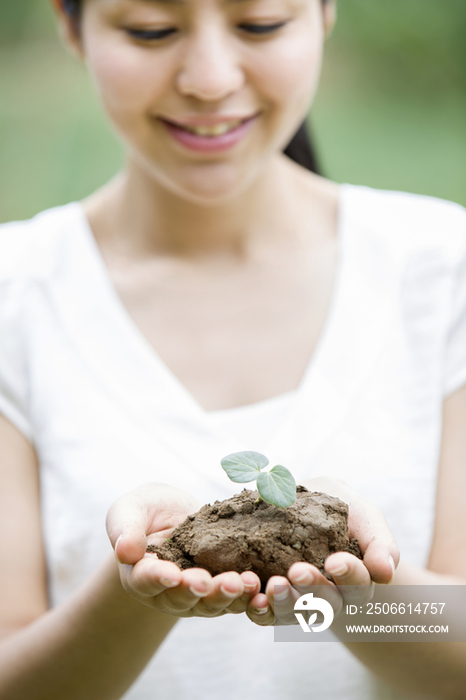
xmin=66 ymin=0 xmax=330 ymax=203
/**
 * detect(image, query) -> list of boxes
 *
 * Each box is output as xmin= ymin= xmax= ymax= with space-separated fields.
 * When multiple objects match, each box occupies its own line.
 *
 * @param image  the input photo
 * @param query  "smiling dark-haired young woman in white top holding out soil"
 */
xmin=0 ymin=0 xmax=466 ymax=700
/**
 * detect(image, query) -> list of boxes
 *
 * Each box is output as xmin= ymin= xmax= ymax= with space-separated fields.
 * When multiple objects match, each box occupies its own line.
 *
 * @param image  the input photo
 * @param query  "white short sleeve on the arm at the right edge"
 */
xmin=444 ymin=219 xmax=466 ymax=396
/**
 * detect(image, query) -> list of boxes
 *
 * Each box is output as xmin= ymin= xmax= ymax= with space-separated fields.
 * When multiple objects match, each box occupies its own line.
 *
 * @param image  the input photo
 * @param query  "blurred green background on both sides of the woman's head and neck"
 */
xmin=0 ymin=0 xmax=466 ymax=221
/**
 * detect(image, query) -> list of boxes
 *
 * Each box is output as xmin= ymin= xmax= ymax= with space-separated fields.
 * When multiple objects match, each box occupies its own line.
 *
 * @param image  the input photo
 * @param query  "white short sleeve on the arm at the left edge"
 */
xmin=0 ymin=280 xmax=32 ymax=440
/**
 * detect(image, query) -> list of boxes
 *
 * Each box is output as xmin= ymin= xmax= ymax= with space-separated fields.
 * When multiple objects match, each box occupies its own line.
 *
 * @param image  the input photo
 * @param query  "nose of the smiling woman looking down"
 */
xmin=177 ymin=26 xmax=244 ymax=102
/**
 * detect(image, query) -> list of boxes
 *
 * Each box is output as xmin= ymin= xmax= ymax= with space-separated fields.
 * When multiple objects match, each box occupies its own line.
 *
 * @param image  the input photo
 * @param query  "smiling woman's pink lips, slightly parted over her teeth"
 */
xmin=160 ymin=115 xmax=257 ymax=153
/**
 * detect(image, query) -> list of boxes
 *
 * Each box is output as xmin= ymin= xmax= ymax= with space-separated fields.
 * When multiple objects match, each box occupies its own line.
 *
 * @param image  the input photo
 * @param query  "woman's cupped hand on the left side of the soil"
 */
xmin=107 ymin=483 xmax=260 ymax=617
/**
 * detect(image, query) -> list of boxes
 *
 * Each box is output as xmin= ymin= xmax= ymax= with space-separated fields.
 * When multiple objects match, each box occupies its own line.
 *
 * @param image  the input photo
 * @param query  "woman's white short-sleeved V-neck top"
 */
xmin=0 ymin=185 xmax=466 ymax=700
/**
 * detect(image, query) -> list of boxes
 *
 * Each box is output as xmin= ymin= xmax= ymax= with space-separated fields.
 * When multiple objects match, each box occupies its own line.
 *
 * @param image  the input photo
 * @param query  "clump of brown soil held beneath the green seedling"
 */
xmin=147 ymin=486 xmax=362 ymax=584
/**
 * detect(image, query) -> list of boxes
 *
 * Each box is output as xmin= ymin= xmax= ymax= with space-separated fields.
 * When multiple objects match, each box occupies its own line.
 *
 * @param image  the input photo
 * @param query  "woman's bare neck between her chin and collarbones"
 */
xmin=84 ymin=156 xmax=336 ymax=259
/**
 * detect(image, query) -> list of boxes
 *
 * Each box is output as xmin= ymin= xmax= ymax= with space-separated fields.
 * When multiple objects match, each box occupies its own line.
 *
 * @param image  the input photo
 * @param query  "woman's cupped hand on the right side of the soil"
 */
xmin=247 ymin=478 xmax=400 ymax=625
